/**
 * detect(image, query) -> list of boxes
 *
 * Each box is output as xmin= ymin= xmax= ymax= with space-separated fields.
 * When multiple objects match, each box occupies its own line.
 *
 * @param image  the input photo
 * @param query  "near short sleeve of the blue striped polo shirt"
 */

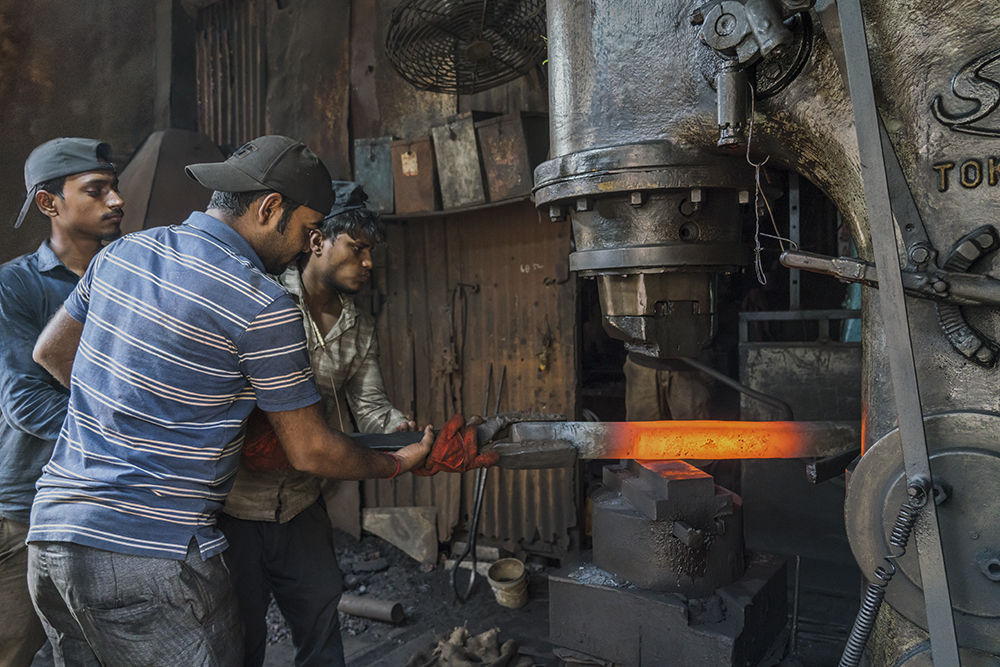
xmin=237 ymin=295 xmax=320 ymax=412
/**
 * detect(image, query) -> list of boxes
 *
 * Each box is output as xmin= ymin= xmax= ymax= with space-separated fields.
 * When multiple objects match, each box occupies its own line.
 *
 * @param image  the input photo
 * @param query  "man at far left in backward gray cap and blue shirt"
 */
xmin=0 ymin=137 xmax=123 ymax=667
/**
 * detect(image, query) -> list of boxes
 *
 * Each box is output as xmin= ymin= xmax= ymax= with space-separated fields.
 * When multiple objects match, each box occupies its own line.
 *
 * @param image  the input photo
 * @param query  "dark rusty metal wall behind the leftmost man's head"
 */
xmin=0 ymin=0 xmax=156 ymax=263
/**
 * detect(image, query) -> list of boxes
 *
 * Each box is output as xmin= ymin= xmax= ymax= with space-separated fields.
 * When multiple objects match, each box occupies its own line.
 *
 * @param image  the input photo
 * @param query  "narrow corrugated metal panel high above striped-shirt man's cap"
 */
xmin=197 ymin=0 xmax=267 ymax=152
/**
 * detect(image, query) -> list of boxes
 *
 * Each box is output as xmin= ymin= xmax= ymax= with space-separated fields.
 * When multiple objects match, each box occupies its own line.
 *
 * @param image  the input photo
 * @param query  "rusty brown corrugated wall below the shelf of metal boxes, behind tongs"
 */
xmin=365 ymin=202 xmax=577 ymax=549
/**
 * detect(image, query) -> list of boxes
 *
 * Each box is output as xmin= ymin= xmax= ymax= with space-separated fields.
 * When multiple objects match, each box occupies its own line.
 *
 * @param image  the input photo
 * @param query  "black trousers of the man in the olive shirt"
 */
xmin=219 ymin=503 xmax=345 ymax=667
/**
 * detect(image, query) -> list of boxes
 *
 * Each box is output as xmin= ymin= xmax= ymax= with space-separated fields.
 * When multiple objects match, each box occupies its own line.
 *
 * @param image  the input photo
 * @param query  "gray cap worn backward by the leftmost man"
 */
xmin=14 ymin=137 xmax=115 ymax=229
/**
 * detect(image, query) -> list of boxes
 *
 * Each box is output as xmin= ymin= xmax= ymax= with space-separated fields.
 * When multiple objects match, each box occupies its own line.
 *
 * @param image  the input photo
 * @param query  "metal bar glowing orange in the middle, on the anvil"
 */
xmin=494 ymin=420 xmax=861 ymax=468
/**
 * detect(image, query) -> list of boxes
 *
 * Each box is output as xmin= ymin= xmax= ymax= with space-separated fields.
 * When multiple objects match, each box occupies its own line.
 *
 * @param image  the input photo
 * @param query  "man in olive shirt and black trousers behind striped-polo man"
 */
xmin=219 ymin=181 xmax=416 ymax=667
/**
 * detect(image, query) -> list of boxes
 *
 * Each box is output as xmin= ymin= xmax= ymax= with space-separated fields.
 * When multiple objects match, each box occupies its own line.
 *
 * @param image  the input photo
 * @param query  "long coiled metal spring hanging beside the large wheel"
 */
xmin=839 ymin=484 xmax=928 ymax=667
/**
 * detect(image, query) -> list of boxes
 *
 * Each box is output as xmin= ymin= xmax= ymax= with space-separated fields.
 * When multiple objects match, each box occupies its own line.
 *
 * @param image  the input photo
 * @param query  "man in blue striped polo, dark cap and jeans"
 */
xmin=28 ymin=136 xmax=433 ymax=667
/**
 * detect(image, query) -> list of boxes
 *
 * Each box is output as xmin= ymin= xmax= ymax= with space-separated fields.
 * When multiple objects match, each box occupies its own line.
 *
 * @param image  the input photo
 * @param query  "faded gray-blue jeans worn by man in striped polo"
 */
xmin=28 ymin=540 xmax=243 ymax=667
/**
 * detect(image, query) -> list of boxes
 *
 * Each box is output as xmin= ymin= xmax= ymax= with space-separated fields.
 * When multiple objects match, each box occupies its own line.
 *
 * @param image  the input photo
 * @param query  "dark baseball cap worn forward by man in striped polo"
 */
xmin=184 ymin=134 xmax=333 ymax=212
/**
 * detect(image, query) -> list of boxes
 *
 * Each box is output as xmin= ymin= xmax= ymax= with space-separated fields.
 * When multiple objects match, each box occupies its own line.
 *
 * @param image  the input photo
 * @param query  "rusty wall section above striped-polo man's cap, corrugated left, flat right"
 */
xmin=197 ymin=0 xmax=351 ymax=178
